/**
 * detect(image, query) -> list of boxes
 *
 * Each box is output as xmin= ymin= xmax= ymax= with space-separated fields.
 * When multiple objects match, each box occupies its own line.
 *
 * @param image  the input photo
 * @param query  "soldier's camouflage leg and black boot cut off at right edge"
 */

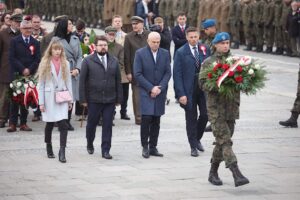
xmin=279 ymin=65 xmax=300 ymax=128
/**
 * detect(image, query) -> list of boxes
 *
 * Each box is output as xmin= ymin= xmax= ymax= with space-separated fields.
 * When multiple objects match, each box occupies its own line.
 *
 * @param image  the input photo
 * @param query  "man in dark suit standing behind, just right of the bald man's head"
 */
xmin=172 ymin=12 xmax=188 ymax=57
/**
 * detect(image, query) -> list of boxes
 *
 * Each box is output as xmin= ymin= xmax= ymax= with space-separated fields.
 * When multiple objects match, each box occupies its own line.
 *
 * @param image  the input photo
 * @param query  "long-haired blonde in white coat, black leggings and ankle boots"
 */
xmin=38 ymin=41 xmax=73 ymax=163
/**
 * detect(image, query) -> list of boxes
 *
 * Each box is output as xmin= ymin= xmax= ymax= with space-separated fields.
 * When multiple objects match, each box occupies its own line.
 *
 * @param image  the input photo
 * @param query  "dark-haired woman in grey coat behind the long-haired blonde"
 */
xmin=52 ymin=18 xmax=82 ymax=131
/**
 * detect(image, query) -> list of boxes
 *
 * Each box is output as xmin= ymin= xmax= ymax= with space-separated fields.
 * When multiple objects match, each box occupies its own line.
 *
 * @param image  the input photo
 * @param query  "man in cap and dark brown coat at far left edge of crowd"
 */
xmin=0 ymin=14 xmax=23 ymax=128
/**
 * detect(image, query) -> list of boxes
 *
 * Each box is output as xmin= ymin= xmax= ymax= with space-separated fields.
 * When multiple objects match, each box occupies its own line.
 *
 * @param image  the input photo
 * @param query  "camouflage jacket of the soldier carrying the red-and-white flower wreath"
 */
xmin=199 ymin=52 xmax=240 ymax=123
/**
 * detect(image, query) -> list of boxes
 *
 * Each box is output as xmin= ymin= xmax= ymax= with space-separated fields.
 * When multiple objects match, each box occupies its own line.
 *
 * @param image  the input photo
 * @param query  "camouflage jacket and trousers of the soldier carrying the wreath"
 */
xmin=200 ymin=52 xmax=240 ymax=167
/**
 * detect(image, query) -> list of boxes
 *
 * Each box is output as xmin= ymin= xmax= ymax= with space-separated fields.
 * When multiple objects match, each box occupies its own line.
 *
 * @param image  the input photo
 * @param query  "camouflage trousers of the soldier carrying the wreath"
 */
xmin=211 ymin=119 xmax=237 ymax=167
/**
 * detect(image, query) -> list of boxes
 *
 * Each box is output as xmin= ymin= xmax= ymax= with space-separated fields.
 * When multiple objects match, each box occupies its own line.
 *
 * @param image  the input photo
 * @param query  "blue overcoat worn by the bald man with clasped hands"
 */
xmin=133 ymin=46 xmax=171 ymax=116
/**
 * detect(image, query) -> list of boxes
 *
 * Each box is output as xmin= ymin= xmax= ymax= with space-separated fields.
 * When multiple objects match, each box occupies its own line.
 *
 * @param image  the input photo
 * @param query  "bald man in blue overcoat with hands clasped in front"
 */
xmin=133 ymin=32 xmax=171 ymax=158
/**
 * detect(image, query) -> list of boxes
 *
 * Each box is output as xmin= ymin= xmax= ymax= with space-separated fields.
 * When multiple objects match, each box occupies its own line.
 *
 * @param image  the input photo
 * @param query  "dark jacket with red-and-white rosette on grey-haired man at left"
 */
xmin=9 ymin=34 xmax=41 ymax=78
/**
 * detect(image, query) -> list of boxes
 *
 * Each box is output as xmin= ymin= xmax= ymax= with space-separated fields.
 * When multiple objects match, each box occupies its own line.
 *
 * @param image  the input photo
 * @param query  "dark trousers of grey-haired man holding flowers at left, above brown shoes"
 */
xmin=9 ymin=101 xmax=28 ymax=125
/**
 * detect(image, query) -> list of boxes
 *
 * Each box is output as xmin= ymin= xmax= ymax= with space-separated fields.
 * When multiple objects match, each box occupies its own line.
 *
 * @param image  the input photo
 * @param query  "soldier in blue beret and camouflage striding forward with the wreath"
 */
xmin=199 ymin=32 xmax=249 ymax=187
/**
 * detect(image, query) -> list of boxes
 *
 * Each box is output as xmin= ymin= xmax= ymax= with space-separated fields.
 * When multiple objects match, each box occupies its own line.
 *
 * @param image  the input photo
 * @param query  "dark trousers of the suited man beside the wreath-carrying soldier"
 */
xmin=184 ymin=88 xmax=208 ymax=148
